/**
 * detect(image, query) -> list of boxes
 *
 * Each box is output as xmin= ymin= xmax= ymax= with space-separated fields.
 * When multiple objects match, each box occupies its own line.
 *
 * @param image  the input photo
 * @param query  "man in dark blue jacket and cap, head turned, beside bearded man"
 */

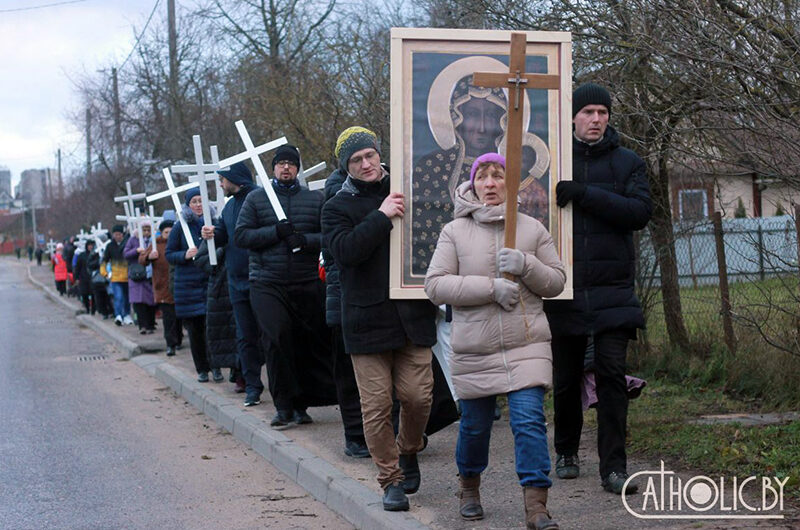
xmin=202 ymin=162 xmax=264 ymax=407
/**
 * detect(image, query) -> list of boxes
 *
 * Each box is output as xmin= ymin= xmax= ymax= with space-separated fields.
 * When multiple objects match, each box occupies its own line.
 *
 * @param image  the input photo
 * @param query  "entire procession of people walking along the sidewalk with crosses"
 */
xmin=42 ymin=84 xmax=652 ymax=530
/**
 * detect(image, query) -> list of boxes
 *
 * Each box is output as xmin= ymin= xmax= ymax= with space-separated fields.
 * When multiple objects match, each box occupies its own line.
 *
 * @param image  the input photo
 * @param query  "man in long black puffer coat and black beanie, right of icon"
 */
xmin=544 ymin=83 xmax=653 ymax=494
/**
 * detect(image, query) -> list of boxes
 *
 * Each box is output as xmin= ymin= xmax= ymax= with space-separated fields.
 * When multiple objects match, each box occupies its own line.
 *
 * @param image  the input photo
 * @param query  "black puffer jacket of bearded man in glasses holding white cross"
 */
xmin=234 ymin=181 xmax=324 ymax=285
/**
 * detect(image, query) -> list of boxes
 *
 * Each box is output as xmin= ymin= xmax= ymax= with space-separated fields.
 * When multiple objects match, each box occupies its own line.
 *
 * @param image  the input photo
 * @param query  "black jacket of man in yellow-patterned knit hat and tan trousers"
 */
xmin=322 ymin=176 xmax=436 ymax=354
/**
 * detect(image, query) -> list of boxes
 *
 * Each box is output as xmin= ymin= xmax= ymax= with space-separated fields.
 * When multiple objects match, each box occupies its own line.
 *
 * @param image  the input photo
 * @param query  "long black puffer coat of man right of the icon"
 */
xmin=544 ymin=126 xmax=653 ymax=335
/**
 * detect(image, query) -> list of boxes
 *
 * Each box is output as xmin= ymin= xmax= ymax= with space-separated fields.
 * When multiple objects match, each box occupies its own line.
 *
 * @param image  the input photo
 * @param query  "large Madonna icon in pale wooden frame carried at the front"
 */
xmin=391 ymin=28 xmax=572 ymax=298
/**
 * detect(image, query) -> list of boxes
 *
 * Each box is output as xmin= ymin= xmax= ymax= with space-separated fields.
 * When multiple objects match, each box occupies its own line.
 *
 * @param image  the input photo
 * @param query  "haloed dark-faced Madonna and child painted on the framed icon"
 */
xmin=411 ymin=56 xmax=550 ymax=277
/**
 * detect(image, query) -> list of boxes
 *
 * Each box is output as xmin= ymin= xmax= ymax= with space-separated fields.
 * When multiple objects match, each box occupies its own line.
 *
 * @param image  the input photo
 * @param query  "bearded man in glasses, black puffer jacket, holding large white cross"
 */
xmin=234 ymin=145 xmax=336 ymax=428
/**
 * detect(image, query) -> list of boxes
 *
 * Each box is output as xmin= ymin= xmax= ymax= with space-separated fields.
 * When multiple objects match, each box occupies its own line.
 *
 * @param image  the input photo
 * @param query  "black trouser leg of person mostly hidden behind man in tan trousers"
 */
xmin=331 ymin=326 xmax=366 ymax=443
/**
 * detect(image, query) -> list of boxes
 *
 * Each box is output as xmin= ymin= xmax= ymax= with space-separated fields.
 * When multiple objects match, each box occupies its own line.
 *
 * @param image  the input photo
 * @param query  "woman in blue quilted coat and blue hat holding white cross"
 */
xmin=167 ymin=188 xmax=216 ymax=383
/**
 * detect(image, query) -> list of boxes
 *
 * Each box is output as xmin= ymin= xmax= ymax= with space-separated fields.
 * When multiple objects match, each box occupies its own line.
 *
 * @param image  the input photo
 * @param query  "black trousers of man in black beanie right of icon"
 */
xmin=552 ymin=329 xmax=632 ymax=478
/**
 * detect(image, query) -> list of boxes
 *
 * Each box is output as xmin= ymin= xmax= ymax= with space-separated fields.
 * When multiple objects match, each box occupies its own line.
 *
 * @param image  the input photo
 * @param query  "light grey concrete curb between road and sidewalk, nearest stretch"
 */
xmin=133 ymin=354 xmax=429 ymax=530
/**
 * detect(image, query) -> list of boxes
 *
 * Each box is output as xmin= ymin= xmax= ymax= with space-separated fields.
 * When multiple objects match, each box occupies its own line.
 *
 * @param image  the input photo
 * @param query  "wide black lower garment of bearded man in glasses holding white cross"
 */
xmin=250 ymin=281 xmax=336 ymax=412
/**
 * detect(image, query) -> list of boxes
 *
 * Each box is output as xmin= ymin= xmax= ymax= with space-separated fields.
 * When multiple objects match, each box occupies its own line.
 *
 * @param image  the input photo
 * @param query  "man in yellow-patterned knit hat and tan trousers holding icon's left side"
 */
xmin=322 ymin=127 xmax=436 ymax=511
